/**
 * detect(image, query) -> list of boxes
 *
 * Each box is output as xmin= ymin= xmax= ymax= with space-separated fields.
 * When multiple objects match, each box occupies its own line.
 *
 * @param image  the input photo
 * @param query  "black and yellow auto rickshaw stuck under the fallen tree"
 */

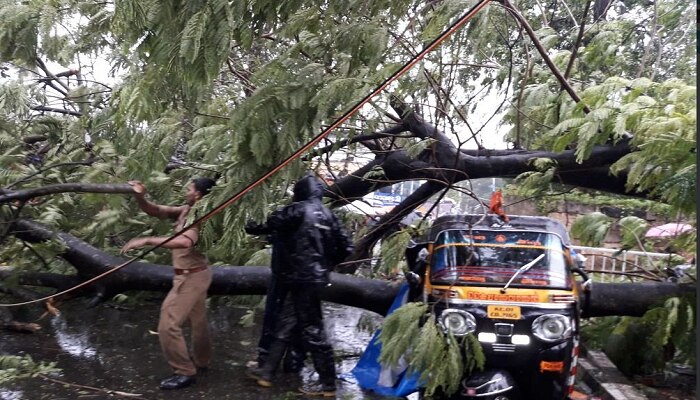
xmin=406 ymin=214 xmax=590 ymax=400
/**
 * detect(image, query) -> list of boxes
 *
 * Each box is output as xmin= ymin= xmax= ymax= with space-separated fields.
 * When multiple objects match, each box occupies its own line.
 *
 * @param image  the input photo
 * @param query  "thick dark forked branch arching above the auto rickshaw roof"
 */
xmin=326 ymin=98 xmax=648 ymax=266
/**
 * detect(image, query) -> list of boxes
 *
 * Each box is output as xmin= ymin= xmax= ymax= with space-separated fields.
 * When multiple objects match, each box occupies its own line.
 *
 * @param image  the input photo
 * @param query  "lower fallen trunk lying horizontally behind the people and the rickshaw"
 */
xmin=0 ymin=220 xmax=695 ymax=317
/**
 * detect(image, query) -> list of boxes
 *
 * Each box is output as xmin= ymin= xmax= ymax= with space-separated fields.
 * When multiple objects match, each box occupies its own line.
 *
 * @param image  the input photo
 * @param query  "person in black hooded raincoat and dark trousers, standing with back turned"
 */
xmin=246 ymin=174 xmax=352 ymax=397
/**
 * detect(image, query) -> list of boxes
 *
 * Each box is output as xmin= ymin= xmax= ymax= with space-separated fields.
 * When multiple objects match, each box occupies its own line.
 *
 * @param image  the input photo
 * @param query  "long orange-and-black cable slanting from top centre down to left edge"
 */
xmin=0 ymin=0 xmax=491 ymax=307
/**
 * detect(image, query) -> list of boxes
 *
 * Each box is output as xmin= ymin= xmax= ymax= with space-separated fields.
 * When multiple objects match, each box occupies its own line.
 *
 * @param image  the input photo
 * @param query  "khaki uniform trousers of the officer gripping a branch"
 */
xmin=158 ymin=268 xmax=212 ymax=376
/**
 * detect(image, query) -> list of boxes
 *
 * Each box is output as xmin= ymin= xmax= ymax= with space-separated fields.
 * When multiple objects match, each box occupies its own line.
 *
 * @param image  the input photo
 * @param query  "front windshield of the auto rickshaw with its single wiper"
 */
xmin=430 ymin=230 xmax=572 ymax=289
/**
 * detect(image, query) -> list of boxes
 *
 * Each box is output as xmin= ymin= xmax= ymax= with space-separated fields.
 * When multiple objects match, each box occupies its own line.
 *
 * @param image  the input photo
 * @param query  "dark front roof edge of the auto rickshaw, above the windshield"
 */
xmin=419 ymin=214 xmax=571 ymax=247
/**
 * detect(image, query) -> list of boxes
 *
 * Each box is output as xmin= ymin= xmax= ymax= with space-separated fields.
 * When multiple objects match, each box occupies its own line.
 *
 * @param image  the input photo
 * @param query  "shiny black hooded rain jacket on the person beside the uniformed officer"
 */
xmin=246 ymin=174 xmax=352 ymax=284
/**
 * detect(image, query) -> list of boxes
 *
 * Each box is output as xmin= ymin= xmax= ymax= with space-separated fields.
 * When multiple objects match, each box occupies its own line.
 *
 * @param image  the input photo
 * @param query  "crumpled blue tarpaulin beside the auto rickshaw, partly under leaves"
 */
xmin=352 ymin=283 xmax=421 ymax=397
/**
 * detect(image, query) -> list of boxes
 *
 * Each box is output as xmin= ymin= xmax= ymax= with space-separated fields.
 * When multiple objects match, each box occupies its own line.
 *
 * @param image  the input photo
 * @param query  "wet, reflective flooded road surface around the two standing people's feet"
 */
xmin=0 ymin=298 xmax=396 ymax=400
